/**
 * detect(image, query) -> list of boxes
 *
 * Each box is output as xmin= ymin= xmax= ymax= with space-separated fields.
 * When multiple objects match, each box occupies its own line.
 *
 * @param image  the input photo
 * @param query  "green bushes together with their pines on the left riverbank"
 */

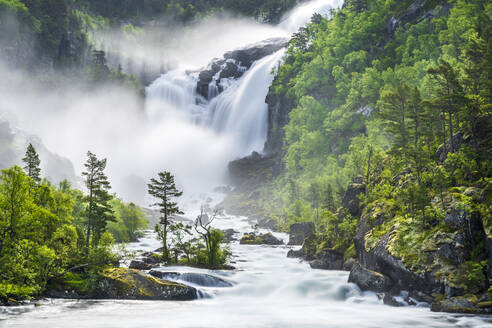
xmin=0 ymin=145 xmax=144 ymax=301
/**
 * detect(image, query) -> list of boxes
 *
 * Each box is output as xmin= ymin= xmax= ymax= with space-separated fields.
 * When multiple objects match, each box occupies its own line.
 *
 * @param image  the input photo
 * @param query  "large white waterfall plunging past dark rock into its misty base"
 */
xmin=141 ymin=0 xmax=342 ymax=195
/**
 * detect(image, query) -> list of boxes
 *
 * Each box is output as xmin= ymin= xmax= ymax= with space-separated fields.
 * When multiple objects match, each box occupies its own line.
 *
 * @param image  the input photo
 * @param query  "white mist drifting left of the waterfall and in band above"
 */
xmin=0 ymin=14 xmax=292 ymax=205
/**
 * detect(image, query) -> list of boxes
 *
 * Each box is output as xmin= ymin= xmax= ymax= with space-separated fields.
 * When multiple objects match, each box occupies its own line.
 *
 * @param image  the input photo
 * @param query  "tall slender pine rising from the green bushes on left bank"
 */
xmin=82 ymin=151 xmax=115 ymax=251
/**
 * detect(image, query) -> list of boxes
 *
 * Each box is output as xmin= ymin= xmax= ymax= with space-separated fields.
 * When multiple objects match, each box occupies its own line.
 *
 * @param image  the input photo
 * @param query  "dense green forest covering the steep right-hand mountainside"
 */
xmin=256 ymin=0 xmax=492 ymax=292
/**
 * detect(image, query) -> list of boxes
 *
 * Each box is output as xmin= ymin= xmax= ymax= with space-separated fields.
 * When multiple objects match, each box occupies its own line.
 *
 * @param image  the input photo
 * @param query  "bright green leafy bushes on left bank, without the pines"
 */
xmin=0 ymin=166 xmax=122 ymax=299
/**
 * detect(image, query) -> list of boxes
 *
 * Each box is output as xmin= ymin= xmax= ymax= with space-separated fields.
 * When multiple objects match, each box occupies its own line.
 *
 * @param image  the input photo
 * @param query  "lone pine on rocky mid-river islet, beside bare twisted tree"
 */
xmin=147 ymin=171 xmax=183 ymax=261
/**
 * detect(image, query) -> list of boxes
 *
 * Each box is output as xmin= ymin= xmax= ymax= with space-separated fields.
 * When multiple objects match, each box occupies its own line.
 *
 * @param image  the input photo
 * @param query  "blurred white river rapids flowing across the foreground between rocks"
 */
xmin=0 ymin=210 xmax=492 ymax=328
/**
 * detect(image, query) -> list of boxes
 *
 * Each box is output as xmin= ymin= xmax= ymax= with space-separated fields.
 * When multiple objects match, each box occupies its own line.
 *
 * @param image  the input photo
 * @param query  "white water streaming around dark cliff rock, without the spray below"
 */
xmin=147 ymin=0 xmax=342 ymax=192
